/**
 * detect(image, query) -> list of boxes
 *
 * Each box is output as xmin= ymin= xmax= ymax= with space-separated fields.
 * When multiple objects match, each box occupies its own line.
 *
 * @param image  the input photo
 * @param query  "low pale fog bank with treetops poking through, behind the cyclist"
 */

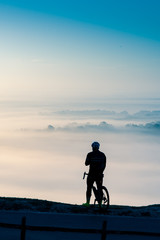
xmin=0 ymin=101 xmax=160 ymax=205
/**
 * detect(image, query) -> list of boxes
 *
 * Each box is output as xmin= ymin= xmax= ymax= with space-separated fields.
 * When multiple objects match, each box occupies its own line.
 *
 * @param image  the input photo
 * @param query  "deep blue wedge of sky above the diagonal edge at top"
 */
xmin=0 ymin=0 xmax=160 ymax=41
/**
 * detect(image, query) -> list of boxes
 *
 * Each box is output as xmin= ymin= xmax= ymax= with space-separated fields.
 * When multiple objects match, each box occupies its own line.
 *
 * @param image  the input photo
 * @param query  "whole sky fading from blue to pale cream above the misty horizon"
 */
xmin=0 ymin=0 xmax=160 ymax=101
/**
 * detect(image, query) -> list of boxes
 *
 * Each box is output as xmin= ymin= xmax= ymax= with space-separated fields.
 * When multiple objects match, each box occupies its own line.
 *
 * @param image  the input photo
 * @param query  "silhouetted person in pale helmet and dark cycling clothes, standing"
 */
xmin=83 ymin=142 xmax=106 ymax=206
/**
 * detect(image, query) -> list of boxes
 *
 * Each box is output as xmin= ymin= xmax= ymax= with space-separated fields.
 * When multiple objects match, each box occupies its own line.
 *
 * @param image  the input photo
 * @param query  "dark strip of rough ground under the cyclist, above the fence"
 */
xmin=0 ymin=197 xmax=160 ymax=218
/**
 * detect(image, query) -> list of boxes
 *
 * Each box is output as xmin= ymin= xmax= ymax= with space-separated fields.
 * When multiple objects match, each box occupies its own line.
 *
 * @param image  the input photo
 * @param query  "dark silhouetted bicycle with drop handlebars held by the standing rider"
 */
xmin=83 ymin=172 xmax=110 ymax=210
